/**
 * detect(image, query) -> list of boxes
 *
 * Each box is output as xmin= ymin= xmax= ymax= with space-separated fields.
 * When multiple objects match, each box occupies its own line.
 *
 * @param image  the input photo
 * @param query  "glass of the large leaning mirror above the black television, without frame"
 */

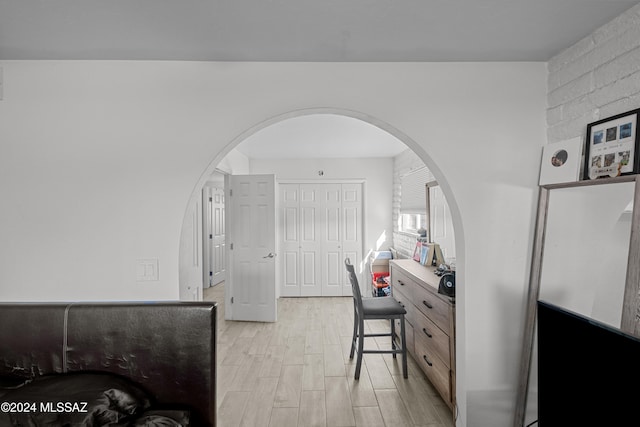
xmin=538 ymin=182 xmax=634 ymax=328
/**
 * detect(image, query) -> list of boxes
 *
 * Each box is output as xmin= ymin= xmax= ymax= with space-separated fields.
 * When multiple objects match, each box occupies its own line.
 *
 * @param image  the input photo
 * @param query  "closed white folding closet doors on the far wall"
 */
xmin=279 ymin=183 xmax=362 ymax=296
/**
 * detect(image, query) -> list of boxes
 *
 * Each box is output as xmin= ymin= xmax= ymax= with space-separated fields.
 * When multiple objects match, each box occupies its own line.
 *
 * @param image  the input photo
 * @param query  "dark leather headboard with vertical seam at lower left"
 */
xmin=0 ymin=302 xmax=216 ymax=426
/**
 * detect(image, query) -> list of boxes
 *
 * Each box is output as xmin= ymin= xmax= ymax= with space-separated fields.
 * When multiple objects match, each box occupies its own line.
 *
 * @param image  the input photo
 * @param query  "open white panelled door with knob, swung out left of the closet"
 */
xmin=225 ymin=175 xmax=277 ymax=322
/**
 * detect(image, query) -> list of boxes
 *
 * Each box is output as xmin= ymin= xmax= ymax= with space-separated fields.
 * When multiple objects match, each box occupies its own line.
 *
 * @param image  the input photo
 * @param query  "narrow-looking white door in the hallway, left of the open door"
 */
xmin=203 ymin=186 xmax=227 ymax=286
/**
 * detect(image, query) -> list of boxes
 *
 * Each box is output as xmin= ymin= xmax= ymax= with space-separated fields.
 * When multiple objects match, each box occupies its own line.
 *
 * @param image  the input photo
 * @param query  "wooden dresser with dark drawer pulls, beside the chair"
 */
xmin=389 ymin=259 xmax=456 ymax=410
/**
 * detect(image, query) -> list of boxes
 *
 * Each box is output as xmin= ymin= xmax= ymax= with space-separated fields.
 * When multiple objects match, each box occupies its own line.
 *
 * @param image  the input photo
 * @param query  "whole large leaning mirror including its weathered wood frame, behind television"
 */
xmin=515 ymin=176 xmax=637 ymax=427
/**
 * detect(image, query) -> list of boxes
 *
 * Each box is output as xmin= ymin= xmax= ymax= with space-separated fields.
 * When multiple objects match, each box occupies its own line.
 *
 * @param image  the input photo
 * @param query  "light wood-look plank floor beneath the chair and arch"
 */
xmin=204 ymin=284 xmax=454 ymax=427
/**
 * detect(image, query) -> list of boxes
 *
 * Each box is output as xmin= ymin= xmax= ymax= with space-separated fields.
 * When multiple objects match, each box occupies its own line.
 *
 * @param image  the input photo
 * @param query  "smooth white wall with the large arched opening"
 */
xmin=0 ymin=61 xmax=546 ymax=427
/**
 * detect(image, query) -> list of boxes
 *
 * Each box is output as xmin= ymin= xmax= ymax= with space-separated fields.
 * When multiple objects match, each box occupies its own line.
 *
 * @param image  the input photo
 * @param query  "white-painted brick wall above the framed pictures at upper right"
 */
xmin=547 ymin=4 xmax=640 ymax=143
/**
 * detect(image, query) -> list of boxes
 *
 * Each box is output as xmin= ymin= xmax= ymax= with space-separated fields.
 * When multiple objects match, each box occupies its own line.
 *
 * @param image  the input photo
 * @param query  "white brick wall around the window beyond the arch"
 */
xmin=392 ymin=149 xmax=435 ymax=257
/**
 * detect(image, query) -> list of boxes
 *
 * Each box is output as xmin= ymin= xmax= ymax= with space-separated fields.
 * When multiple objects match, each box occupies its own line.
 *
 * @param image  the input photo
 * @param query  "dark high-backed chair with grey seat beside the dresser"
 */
xmin=344 ymin=258 xmax=407 ymax=379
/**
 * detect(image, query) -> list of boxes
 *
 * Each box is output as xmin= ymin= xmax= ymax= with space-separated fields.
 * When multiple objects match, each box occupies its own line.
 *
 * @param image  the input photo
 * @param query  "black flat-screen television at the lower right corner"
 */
xmin=538 ymin=301 xmax=640 ymax=427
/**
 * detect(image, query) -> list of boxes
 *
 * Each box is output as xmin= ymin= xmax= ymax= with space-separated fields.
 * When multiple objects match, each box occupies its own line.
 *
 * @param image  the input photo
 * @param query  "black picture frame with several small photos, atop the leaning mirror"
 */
xmin=582 ymin=108 xmax=640 ymax=180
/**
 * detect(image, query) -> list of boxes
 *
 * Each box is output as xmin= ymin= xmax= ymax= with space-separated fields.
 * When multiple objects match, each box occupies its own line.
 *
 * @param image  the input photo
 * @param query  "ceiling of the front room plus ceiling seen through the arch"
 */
xmin=0 ymin=0 xmax=638 ymax=158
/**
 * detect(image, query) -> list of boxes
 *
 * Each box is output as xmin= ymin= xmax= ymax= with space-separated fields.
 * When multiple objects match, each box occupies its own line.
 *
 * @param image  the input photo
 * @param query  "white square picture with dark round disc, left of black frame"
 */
xmin=538 ymin=137 xmax=582 ymax=186
